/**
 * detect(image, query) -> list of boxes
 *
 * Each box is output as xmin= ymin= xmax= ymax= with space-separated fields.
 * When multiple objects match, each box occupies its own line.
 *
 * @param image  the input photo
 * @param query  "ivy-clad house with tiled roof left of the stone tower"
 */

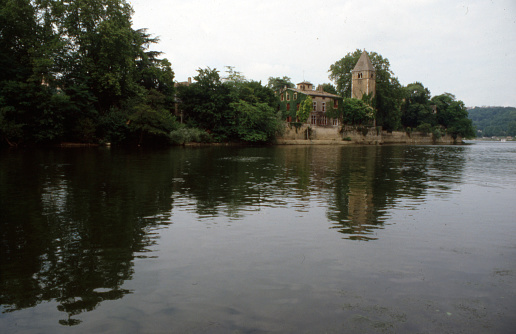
xmin=277 ymin=81 xmax=342 ymax=126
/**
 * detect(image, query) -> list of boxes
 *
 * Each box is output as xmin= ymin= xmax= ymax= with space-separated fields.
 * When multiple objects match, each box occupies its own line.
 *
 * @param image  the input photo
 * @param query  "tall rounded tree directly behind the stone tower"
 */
xmin=328 ymin=49 xmax=403 ymax=131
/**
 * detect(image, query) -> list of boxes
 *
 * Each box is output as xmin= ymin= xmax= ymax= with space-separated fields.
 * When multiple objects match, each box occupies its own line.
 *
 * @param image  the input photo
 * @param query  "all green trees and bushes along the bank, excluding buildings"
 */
xmin=0 ymin=0 xmax=475 ymax=146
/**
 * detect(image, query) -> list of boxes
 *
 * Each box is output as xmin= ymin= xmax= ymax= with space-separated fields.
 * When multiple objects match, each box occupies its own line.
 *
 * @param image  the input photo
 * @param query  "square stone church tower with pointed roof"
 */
xmin=351 ymin=50 xmax=376 ymax=99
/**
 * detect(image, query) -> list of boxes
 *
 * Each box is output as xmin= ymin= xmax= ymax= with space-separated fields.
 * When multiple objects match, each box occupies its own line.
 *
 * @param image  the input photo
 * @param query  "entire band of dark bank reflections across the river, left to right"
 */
xmin=0 ymin=146 xmax=515 ymax=332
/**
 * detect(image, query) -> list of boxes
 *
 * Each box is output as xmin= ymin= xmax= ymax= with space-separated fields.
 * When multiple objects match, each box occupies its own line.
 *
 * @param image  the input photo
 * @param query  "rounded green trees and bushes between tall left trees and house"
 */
xmin=178 ymin=67 xmax=280 ymax=142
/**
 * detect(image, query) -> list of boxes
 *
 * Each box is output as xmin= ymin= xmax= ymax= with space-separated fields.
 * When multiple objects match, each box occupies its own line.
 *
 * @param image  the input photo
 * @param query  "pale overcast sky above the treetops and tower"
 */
xmin=128 ymin=0 xmax=516 ymax=107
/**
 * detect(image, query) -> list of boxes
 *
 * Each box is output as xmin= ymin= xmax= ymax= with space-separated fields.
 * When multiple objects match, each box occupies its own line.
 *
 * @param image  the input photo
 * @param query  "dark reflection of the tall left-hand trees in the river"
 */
xmin=0 ymin=150 xmax=173 ymax=325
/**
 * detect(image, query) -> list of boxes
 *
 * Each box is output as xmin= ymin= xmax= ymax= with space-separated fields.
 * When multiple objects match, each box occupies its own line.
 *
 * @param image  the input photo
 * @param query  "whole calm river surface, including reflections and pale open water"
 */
xmin=0 ymin=143 xmax=516 ymax=333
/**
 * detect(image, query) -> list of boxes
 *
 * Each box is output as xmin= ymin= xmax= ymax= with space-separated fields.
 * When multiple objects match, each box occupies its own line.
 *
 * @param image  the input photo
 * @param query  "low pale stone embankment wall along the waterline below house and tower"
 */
xmin=277 ymin=124 xmax=462 ymax=145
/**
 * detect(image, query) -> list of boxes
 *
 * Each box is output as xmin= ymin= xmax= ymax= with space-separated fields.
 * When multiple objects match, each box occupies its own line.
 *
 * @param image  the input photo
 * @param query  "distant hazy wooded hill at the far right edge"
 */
xmin=468 ymin=107 xmax=516 ymax=137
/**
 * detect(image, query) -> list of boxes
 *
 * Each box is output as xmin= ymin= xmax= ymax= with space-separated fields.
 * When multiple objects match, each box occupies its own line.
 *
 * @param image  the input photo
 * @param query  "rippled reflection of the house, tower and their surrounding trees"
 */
xmin=168 ymin=146 xmax=467 ymax=240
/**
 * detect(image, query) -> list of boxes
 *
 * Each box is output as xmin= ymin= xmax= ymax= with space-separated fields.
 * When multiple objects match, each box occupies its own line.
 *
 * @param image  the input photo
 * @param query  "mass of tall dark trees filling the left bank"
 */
xmin=0 ymin=0 xmax=174 ymax=145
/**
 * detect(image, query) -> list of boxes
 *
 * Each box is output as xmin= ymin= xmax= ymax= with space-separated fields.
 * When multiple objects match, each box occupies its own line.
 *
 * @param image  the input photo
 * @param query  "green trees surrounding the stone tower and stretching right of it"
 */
xmin=329 ymin=49 xmax=475 ymax=138
